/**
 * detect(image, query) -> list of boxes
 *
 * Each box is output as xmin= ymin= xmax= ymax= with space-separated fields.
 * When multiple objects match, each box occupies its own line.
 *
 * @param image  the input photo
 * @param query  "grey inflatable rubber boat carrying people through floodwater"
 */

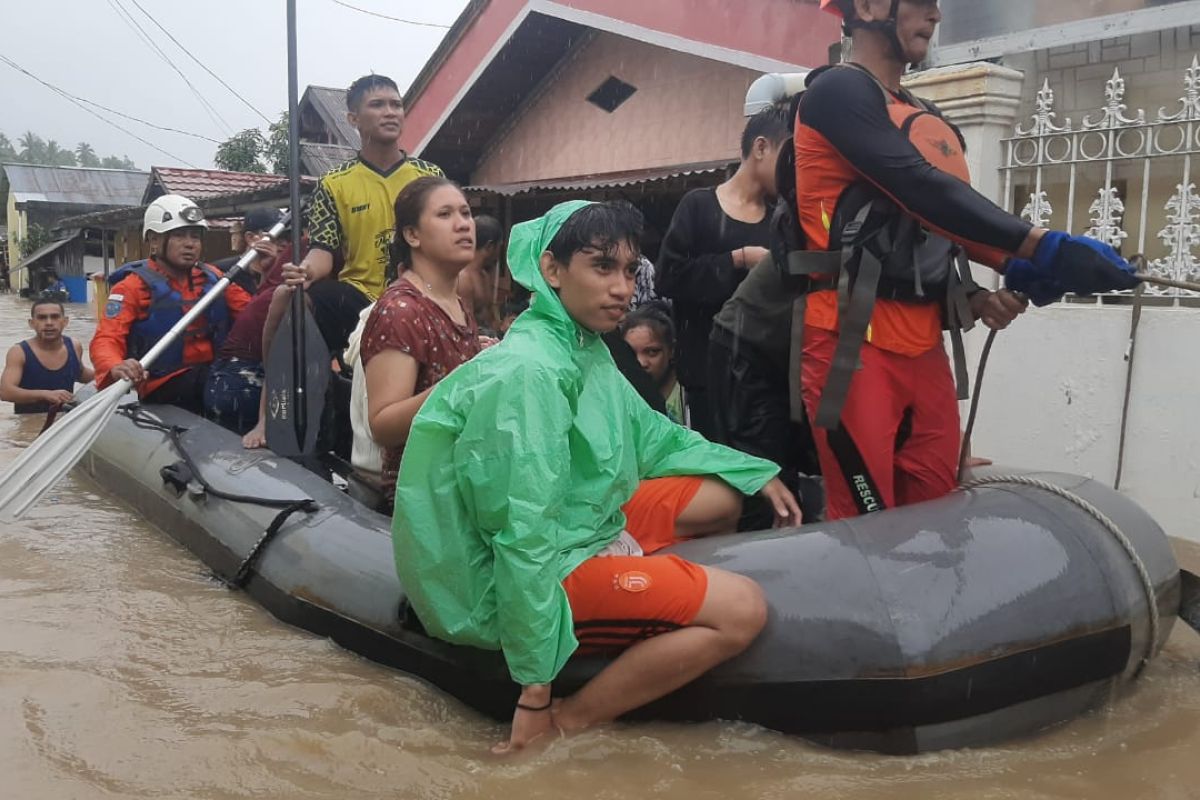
xmin=82 ymin=405 xmax=1181 ymax=753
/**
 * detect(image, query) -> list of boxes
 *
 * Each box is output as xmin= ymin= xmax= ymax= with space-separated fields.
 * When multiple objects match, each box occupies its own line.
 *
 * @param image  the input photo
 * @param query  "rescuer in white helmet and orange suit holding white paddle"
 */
xmin=90 ymin=194 xmax=250 ymax=414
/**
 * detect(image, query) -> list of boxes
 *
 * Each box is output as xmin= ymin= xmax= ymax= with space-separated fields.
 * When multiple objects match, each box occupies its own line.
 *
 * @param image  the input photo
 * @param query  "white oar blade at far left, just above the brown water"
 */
xmin=0 ymin=380 xmax=130 ymax=522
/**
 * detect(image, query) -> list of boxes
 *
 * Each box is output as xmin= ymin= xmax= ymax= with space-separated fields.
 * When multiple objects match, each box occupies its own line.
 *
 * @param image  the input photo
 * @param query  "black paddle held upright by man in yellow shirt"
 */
xmin=264 ymin=0 xmax=330 ymax=458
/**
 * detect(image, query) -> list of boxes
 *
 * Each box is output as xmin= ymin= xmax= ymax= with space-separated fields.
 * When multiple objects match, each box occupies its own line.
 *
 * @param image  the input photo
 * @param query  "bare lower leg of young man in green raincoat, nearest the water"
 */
xmin=554 ymin=566 xmax=767 ymax=733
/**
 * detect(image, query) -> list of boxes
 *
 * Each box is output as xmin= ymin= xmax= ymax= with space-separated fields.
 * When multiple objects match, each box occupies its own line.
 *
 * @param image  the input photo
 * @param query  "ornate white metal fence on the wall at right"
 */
xmin=1003 ymin=58 xmax=1200 ymax=298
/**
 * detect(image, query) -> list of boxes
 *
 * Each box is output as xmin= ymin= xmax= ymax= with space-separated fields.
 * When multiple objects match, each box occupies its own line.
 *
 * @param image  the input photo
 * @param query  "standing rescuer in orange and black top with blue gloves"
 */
xmin=782 ymin=0 xmax=1138 ymax=518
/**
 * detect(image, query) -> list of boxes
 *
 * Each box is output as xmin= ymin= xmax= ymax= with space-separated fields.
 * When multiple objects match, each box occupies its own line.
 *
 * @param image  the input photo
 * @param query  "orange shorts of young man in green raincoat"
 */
xmin=563 ymin=476 xmax=708 ymax=654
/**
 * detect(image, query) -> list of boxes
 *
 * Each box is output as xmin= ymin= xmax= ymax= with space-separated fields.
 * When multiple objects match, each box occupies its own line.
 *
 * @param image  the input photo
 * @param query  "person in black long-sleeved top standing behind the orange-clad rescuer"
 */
xmin=655 ymin=110 xmax=790 ymax=438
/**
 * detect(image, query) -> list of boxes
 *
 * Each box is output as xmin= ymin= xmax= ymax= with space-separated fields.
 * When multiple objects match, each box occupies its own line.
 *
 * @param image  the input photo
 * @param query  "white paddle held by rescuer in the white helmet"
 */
xmin=0 ymin=215 xmax=290 ymax=522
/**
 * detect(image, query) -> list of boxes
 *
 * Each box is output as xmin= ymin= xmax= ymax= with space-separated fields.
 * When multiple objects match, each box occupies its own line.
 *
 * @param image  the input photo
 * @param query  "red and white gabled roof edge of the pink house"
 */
xmin=401 ymin=0 xmax=839 ymax=160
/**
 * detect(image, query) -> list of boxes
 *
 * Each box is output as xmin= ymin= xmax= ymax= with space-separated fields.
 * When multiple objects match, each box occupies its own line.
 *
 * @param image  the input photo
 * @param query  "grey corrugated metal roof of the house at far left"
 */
xmin=2 ymin=163 xmax=150 ymax=207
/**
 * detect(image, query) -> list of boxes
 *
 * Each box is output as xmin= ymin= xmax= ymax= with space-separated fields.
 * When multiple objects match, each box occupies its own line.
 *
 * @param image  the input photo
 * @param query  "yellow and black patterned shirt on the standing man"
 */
xmin=308 ymin=157 xmax=443 ymax=302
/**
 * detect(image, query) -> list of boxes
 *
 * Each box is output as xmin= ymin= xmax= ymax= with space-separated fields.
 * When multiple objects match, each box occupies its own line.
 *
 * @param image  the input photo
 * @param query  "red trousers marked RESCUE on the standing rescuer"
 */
xmin=800 ymin=326 xmax=960 ymax=519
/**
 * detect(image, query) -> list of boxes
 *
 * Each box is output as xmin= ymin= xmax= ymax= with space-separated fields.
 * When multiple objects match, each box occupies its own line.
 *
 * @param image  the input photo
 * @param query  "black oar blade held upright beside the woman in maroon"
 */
xmin=264 ymin=306 xmax=330 ymax=458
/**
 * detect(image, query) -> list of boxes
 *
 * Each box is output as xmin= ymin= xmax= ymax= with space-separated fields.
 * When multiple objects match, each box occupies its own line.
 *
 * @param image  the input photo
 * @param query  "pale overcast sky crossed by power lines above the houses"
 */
xmin=0 ymin=0 xmax=467 ymax=169
